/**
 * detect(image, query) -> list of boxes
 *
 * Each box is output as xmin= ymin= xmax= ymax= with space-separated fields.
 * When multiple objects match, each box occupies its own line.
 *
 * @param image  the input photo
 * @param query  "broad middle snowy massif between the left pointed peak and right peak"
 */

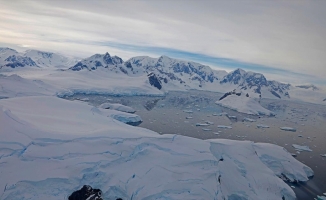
xmin=125 ymin=56 xmax=227 ymax=89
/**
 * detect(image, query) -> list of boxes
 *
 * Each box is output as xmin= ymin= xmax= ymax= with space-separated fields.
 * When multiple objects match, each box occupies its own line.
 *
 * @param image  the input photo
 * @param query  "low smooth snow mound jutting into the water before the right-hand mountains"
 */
xmin=215 ymin=94 xmax=274 ymax=116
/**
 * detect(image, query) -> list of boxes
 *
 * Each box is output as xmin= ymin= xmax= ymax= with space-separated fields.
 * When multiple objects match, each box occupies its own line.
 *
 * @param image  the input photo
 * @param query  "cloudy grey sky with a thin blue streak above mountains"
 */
xmin=0 ymin=0 xmax=326 ymax=85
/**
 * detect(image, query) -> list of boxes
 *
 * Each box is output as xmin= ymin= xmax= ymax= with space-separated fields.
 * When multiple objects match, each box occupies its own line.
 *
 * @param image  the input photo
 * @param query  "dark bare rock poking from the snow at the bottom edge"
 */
xmin=68 ymin=185 xmax=103 ymax=200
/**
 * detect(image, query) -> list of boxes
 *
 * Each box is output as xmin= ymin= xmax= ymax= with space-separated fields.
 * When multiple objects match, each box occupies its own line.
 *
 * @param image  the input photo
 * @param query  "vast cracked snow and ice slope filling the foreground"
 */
xmin=0 ymin=96 xmax=313 ymax=200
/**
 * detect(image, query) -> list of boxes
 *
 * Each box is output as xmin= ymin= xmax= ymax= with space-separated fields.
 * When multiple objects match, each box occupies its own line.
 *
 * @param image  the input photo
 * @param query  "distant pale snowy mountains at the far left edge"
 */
xmin=0 ymin=48 xmax=77 ymax=69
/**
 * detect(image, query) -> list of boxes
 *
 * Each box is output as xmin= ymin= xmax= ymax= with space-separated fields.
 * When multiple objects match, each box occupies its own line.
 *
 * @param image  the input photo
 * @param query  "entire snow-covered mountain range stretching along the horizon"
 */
xmin=0 ymin=48 xmax=324 ymax=99
